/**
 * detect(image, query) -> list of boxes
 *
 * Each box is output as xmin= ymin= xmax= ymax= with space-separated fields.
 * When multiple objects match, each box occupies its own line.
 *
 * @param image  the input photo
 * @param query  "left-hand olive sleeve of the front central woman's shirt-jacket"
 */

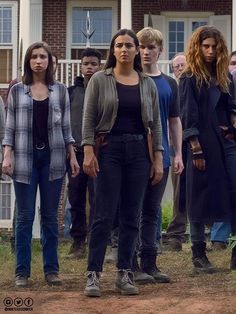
xmin=81 ymin=75 xmax=99 ymax=146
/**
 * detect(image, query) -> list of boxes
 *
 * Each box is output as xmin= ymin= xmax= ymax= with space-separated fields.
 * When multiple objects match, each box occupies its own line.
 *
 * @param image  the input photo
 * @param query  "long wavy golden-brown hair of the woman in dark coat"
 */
xmin=184 ymin=26 xmax=229 ymax=92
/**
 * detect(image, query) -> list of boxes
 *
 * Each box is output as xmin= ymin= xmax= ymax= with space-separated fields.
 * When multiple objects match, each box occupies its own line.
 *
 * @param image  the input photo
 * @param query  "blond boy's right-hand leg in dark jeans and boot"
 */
xmin=140 ymin=168 xmax=170 ymax=282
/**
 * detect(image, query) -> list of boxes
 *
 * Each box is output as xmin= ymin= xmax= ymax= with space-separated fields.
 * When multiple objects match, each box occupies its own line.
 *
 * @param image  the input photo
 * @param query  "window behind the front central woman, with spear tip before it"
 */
xmin=67 ymin=0 xmax=118 ymax=59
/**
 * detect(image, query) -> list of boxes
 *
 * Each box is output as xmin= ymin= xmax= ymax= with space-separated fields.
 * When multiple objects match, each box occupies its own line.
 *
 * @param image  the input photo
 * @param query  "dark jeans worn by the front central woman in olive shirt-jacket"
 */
xmin=88 ymin=134 xmax=150 ymax=272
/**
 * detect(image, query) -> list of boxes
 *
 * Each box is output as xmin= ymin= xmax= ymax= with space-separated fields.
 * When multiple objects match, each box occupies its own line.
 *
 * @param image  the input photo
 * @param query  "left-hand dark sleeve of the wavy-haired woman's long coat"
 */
xmin=179 ymin=75 xmax=199 ymax=140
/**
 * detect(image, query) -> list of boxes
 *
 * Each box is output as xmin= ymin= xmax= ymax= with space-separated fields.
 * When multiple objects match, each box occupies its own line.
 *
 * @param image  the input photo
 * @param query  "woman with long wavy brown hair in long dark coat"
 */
xmin=179 ymin=26 xmax=236 ymax=273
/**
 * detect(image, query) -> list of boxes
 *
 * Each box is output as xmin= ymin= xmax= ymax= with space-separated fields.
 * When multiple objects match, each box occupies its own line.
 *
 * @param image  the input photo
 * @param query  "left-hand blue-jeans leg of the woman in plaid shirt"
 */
xmin=14 ymin=169 xmax=38 ymax=285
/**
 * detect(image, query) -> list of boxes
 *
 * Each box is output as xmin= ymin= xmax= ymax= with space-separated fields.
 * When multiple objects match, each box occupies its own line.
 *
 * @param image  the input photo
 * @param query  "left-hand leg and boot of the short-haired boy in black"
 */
xmin=68 ymin=152 xmax=88 ymax=251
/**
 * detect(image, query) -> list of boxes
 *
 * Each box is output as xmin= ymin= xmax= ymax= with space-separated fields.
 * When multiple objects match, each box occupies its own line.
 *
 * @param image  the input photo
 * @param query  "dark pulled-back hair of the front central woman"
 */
xmin=104 ymin=28 xmax=142 ymax=71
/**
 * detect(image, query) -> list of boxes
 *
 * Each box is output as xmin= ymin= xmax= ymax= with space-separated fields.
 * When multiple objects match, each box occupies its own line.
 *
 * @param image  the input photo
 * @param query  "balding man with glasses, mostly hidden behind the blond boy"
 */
xmin=163 ymin=52 xmax=187 ymax=251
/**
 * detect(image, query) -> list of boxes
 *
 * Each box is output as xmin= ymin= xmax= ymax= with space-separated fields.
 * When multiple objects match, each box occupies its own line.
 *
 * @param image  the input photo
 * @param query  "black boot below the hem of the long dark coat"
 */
xmin=192 ymin=242 xmax=216 ymax=274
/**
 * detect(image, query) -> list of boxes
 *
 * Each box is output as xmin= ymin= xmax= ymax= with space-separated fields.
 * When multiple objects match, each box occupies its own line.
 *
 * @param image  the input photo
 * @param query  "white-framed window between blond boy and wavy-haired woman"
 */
xmin=167 ymin=18 xmax=208 ymax=59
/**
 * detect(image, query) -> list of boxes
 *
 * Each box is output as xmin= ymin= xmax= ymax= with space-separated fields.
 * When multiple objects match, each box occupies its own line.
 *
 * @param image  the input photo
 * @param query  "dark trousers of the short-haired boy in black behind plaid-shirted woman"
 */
xmin=68 ymin=152 xmax=94 ymax=243
